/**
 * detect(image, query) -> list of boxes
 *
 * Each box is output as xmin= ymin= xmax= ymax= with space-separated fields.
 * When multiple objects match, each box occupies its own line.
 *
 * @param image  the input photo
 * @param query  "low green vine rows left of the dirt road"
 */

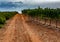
xmin=0 ymin=12 xmax=17 ymax=28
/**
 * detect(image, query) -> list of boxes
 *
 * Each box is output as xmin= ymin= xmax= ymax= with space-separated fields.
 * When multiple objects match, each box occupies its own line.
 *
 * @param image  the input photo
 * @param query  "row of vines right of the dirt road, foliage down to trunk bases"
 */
xmin=22 ymin=7 xmax=60 ymax=28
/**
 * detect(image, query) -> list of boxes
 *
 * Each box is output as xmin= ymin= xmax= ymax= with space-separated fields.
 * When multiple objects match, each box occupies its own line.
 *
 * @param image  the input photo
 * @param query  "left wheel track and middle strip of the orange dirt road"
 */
xmin=1 ymin=14 xmax=31 ymax=42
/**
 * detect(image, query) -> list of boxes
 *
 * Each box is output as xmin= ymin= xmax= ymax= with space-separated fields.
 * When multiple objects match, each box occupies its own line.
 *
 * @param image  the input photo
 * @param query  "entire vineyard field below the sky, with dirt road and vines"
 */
xmin=0 ymin=7 xmax=60 ymax=42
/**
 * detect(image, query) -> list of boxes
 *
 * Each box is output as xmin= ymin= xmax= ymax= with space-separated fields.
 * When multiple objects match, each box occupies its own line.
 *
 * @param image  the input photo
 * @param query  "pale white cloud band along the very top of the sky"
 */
xmin=0 ymin=0 xmax=60 ymax=5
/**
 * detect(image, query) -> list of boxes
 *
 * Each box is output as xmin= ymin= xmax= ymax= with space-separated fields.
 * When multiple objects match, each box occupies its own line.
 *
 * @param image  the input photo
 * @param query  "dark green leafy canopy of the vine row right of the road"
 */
xmin=22 ymin=7 xmax=60 ymax=27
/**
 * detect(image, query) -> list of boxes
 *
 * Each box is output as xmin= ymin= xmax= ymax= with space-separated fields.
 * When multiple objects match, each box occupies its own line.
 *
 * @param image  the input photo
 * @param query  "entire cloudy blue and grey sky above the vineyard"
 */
xmin=0 ymin=0 xmax=60 ymax=12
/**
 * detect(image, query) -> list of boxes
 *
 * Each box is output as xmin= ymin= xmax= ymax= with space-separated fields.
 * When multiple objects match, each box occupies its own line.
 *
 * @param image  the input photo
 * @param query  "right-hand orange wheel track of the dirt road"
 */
xmin=21 ymin=15 xmax=42 ymax=42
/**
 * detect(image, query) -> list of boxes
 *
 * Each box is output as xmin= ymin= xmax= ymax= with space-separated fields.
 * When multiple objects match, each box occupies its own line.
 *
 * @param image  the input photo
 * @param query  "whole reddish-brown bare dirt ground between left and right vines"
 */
xmin=0 ymin=14 xmax=60 ymax=42
